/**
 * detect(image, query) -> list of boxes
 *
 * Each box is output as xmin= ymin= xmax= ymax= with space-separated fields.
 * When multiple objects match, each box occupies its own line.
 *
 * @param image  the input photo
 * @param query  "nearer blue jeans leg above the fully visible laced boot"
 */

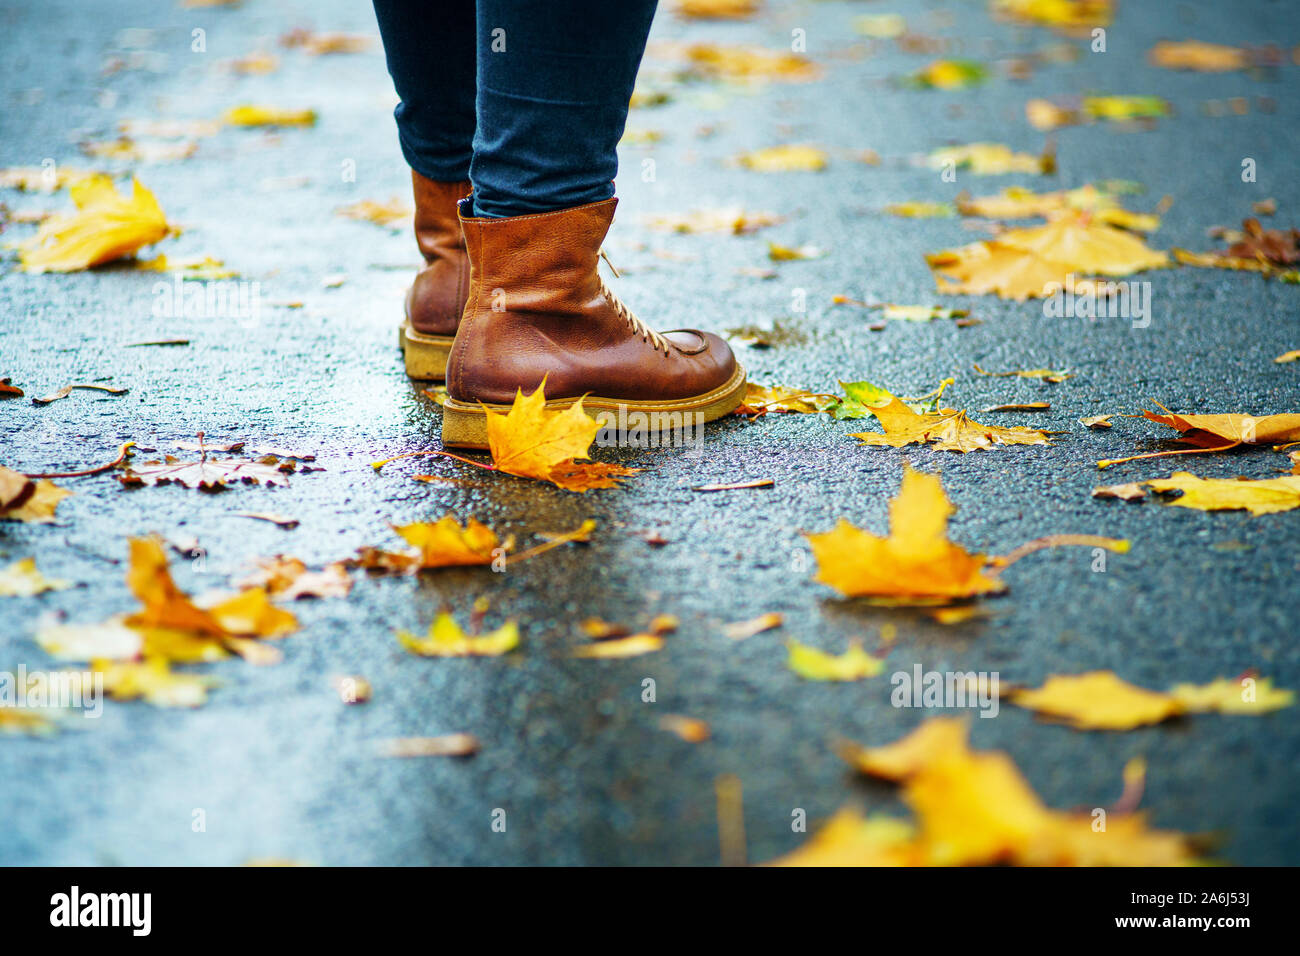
xmin=469 ymin=0 xmax=657 ymax=217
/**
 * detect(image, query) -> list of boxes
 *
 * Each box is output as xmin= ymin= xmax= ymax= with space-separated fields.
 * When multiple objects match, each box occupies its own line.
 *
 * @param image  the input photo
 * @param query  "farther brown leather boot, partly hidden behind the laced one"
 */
xmin=398 ymin=170 xmax=469 ymax=378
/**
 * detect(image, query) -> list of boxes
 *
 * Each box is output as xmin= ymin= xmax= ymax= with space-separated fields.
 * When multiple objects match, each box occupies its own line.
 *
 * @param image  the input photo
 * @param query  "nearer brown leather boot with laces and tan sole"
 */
xmin=442 ymin=199 xmax=745 ymax=447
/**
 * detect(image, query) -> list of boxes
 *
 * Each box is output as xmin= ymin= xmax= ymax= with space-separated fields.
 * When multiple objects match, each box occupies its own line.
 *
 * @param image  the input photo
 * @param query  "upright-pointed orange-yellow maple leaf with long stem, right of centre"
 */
xmin=805 ymin=464 xmax=1005 ymax=604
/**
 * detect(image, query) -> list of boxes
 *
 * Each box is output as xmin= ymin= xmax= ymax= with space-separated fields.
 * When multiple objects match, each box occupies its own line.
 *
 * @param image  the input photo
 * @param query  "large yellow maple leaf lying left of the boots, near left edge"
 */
xmin=18 ymin=176 xmax=169 ymax=272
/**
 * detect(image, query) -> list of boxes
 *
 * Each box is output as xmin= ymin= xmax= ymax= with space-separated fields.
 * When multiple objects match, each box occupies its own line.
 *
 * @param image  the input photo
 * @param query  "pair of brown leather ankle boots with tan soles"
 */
xmin=400 ymin=173 xmax=745 ymax=449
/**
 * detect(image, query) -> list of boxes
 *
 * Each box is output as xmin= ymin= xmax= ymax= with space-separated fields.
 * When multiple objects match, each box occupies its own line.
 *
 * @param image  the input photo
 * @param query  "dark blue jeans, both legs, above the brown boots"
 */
xmin=374 ymin=0 xmax=657 ymax=217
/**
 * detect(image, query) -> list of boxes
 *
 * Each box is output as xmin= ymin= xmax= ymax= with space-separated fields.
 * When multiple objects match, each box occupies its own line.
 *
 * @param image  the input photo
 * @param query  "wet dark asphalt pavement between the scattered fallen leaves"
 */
xmin=0 ymin=0 xmax=1300 ymax=865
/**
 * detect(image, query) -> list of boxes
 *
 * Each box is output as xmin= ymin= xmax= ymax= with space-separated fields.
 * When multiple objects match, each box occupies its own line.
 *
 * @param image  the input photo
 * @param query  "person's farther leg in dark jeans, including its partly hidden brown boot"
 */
xmin=374 ymin=0 xmax=475 ymax=380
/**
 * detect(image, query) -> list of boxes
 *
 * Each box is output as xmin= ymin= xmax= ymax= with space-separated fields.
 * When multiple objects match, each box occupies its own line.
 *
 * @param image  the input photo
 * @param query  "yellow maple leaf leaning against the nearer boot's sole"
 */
xmin=488 ymin=381 xmax=637 ymax=492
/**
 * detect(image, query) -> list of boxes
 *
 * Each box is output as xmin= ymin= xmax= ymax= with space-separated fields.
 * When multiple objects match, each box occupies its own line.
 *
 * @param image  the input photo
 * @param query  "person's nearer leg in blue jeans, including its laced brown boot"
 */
xmin=442 ymin=0 xmax=745 ymax=447
